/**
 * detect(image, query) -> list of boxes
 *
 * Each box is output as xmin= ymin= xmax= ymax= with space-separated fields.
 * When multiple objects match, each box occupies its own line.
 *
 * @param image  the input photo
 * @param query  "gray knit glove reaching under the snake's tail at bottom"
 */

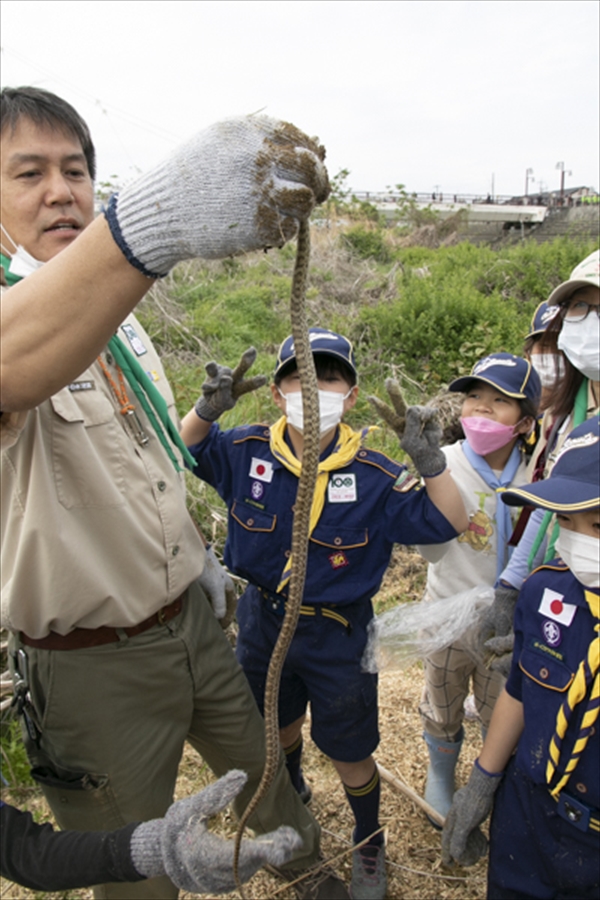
xmin=130 ymin=769 xmax=302 ymax=895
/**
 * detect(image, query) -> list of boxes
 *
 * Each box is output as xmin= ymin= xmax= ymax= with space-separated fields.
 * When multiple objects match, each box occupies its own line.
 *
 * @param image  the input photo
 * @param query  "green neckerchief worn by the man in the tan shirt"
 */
xmin=0 ymin=253 xmax=196 ymax=472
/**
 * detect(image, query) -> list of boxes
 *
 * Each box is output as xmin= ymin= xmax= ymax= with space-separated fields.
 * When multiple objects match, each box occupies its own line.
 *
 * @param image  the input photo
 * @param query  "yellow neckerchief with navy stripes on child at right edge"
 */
xmin=546 ymin=591 xmax=600 ymax=798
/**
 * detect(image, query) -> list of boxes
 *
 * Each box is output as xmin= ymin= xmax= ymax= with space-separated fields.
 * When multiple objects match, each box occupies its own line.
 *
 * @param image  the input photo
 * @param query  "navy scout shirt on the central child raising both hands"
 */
xmin=189 ymin=423 xmax=457 ymax=605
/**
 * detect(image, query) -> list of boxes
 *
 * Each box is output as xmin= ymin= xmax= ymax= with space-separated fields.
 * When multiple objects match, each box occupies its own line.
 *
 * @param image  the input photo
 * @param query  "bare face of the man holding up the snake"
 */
xmin=0 ymin=118 xmax=94 ymax=262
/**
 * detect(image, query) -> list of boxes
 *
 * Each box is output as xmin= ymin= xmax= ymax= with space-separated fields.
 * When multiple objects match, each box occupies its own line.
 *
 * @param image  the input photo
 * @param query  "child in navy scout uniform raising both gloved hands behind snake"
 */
xmin=182 ymin=328 xmax=467 ymax=900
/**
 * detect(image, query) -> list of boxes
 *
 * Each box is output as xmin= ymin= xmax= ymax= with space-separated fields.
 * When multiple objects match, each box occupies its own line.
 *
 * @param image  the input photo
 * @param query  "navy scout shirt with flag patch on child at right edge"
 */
xmin=506 ymin=560 xmax=600 ymax=808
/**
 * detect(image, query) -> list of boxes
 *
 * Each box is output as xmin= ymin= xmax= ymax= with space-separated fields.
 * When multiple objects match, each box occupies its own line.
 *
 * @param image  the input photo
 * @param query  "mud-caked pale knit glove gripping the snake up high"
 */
xmin=106 ymin=116 xmax=329 ymax=278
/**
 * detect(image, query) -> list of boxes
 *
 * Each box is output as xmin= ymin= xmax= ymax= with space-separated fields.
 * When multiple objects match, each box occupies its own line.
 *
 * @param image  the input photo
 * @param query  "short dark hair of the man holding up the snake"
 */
xmin=0 ymin=87 xmax=96 ymax=181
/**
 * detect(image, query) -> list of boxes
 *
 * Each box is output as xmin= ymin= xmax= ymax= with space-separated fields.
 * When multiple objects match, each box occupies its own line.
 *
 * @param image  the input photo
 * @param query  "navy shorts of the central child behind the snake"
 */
xmin=236 ymin=585 xmax=379 ymax=762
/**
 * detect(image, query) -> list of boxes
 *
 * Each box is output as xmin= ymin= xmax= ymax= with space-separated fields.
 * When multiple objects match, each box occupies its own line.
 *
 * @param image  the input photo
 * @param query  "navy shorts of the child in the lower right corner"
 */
xmin=488 ymin=759 xmax=600 ymax=900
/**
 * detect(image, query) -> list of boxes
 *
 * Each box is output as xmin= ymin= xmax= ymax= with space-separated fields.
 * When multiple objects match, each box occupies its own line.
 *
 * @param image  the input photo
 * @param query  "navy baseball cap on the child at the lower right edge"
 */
xmin=500 ymin=416 xmax=600 ymax=512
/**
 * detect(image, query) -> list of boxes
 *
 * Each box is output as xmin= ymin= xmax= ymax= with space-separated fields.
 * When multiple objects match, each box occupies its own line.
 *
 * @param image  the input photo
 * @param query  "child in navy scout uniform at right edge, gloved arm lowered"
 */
xmin=442 ymin=416 xmax=600 ymax=900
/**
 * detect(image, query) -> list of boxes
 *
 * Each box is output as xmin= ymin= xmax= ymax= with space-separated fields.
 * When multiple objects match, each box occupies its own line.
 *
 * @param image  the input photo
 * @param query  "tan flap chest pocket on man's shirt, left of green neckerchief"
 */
xmin=49 ymin=380 xmax=130 ymax=509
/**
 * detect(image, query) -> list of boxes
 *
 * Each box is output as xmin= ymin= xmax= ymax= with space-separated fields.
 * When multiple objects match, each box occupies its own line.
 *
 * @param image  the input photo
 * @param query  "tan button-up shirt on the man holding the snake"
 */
xmin=0 ymin=315 xmax=204 ymax=638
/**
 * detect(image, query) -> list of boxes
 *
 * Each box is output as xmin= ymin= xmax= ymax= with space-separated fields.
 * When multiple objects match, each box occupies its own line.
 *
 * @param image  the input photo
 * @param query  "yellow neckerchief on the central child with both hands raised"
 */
xmin=270 ymin=416 xmax=377 ymax=593
